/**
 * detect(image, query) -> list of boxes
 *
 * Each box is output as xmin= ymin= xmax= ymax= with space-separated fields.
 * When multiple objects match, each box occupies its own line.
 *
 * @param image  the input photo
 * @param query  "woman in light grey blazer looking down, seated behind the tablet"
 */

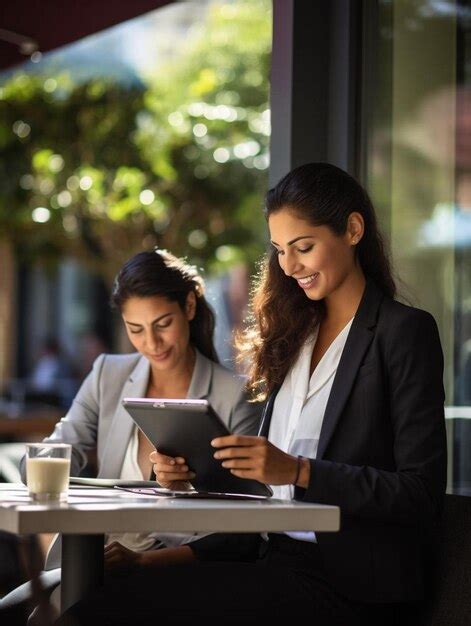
xmin=3 ymin=250 xmax=261 ymax=616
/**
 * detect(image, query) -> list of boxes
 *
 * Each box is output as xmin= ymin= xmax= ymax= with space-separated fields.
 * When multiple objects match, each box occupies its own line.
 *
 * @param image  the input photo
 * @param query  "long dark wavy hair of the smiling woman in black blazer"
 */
xmin=237 ymin=163 xmax=396 ymax=399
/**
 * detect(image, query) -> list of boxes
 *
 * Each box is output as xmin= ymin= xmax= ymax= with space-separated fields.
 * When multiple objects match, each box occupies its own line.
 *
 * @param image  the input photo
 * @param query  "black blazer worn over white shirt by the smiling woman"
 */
xmin=191 ymin=281 xmax=447 ymax=602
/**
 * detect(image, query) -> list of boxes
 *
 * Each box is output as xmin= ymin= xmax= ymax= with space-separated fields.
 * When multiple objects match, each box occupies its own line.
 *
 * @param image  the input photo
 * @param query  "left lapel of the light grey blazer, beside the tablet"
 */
xmin=98 ymin=357 xmax=150 ymax=478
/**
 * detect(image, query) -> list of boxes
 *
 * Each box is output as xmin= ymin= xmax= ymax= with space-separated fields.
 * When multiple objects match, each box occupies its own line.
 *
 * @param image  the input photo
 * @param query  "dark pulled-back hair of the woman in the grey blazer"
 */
xmin=111 ymin=249 xmax=219 ymax=363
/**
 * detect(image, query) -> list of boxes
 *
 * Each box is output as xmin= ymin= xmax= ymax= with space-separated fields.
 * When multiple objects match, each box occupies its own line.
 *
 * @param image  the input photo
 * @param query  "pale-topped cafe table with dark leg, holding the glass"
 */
xmin=0 ymin=483 xmax=340 ymax=610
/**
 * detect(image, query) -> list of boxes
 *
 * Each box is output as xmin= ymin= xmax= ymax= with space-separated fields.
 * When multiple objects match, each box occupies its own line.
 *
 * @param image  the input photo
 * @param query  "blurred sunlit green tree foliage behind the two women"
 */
xmin=0 ymin=0 xmax=271 ymax=279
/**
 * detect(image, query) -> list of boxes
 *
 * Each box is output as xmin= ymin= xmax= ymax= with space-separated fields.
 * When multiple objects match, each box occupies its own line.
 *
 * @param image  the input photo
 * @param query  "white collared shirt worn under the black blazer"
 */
xmin=268 ymin=318 xmax=353 ymax=542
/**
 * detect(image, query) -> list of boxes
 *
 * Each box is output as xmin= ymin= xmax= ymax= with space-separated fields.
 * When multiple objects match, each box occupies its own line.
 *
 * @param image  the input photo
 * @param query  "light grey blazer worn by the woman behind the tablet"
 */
xmin=20 ymin=350 xmax=262 ymax=569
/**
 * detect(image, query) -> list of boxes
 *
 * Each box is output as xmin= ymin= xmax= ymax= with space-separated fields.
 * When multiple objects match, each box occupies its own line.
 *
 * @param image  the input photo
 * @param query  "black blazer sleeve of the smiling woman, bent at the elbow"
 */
xmin=295 ymin=310 xmax=446 ymax=526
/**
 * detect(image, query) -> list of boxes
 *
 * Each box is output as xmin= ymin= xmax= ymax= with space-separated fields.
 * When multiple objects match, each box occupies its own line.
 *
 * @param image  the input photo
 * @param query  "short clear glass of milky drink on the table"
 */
xmin=26 ymin=443 xmax=72 ymax=502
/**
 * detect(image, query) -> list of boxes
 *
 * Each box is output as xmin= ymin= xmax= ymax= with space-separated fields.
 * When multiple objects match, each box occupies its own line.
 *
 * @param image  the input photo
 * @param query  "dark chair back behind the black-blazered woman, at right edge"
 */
xmin=417 ymin=495 xmax=471 ymax=626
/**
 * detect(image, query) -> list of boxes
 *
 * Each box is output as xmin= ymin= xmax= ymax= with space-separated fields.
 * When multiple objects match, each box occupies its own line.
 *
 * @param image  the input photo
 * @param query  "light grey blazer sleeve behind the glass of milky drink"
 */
xmin=20 ymin=354 xmax=106 ymax=482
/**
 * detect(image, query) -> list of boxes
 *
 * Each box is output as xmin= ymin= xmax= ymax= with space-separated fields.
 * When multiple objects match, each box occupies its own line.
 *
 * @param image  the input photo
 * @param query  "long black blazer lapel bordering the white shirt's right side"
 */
xmin=317 ymin=281 xmax=384 ymax=459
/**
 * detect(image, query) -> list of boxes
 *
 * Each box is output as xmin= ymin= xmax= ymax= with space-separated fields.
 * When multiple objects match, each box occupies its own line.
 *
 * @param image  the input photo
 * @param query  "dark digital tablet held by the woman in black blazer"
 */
xmin=122 ymin=398 xmax=273 ymax=497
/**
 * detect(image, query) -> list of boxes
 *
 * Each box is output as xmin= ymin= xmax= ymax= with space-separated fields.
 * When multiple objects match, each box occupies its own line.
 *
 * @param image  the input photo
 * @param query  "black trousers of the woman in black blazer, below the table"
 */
xmin=59 ymin=534 xmax=406 ymax=626
